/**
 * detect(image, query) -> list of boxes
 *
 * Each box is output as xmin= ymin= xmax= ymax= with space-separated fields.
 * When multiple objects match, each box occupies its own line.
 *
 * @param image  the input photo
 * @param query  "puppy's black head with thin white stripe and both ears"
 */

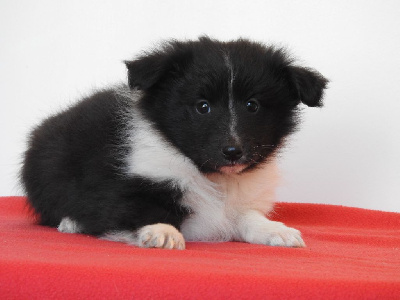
xmin=126 ymin=37 xmax=328 ymax=173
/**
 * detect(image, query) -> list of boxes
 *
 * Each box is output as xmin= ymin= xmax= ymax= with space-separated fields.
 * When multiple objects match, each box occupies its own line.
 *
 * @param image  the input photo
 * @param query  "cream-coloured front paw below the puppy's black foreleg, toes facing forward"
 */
xmin=137 ymin=223 xmax=185 ymax=250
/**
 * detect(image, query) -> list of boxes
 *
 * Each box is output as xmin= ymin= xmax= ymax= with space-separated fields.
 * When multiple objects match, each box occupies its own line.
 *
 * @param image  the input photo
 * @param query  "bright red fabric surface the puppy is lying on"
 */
xmin=0 ymin=197 xmax=400 ymax=299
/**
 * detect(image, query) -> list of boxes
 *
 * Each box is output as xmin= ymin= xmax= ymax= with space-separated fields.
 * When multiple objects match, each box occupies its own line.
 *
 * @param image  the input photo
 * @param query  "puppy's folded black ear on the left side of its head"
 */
xmin=125 ymin=42 xmax=191 ymax=90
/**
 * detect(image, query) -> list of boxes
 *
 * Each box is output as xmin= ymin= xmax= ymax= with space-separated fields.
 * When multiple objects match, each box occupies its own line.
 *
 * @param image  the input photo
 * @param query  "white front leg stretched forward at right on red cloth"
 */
xmin=238 ymin=210 xmax=306 ymax=247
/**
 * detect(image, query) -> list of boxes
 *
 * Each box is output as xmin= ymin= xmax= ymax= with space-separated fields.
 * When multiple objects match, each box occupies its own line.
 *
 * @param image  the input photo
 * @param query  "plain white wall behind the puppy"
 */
xmin=0 ymin=0 xmax=400 ymax=211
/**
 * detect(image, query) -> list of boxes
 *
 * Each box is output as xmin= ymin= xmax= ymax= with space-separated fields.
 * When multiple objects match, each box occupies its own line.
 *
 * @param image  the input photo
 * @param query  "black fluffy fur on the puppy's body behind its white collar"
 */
xmin=22 ymin=91 xmax=187 ymax=235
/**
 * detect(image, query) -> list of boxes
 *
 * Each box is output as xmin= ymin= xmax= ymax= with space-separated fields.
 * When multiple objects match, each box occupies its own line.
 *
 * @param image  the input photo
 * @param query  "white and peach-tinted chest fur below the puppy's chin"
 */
xmin=181 ymin=163 xmax=278 ymax=241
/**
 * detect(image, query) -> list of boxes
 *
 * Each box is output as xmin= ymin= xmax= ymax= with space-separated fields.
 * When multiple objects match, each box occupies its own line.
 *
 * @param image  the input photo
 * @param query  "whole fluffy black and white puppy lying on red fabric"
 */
xmin=21 ymin=37 xmax=327 ymax=249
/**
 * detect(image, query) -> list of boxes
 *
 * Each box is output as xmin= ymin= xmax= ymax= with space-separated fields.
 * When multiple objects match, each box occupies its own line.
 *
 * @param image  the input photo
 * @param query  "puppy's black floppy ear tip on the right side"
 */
xmin=289 ymin=66 xmax=329 ymax=107
